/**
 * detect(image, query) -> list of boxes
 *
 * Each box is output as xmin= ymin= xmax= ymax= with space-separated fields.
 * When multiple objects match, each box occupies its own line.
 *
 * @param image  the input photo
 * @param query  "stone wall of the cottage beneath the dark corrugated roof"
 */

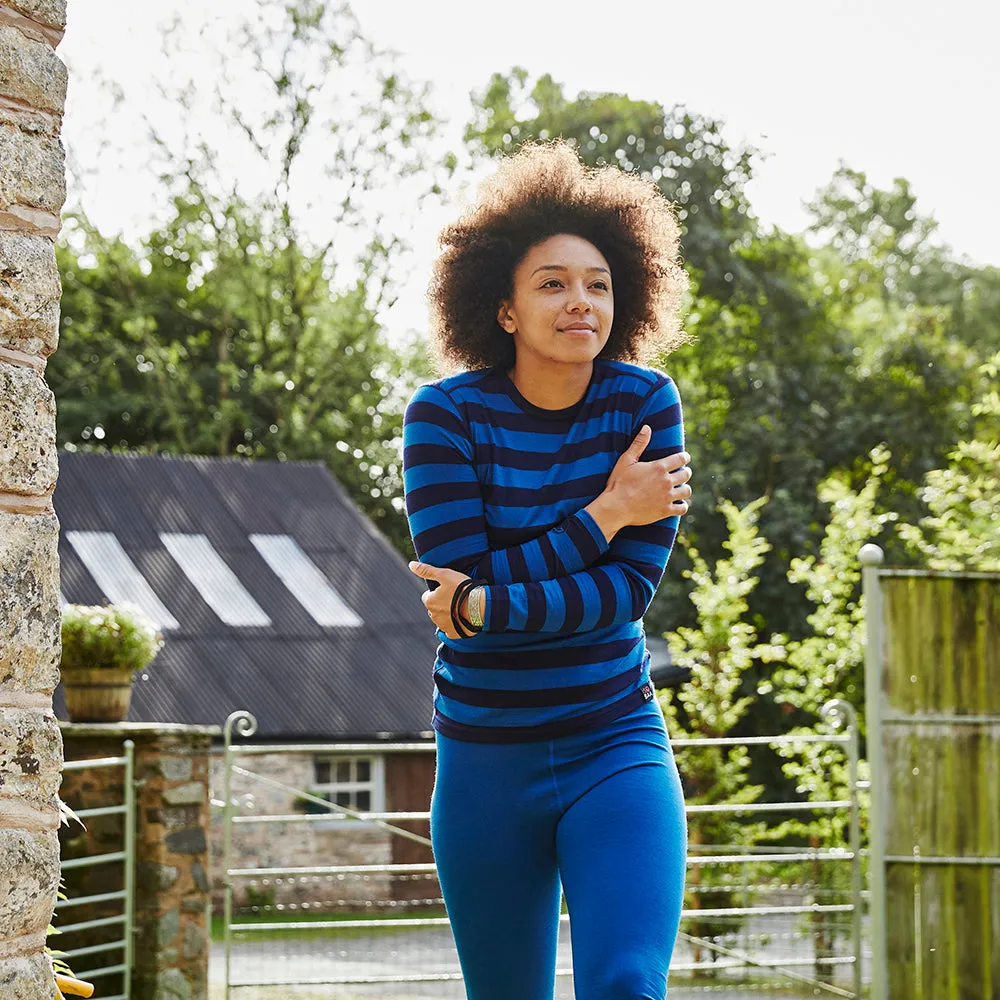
xmin=210 ymin=750 xmax=440 ymax=912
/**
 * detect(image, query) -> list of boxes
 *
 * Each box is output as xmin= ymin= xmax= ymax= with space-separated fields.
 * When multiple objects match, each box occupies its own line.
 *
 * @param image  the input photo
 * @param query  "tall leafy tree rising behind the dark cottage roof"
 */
xmin=50 ymin=0 xmax=446 ymax=551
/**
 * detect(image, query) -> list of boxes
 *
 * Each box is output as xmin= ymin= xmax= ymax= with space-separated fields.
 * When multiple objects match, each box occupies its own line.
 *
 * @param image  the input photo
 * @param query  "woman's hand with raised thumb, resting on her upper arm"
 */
xmin=587 ymin=424 xmax=691 ymax=540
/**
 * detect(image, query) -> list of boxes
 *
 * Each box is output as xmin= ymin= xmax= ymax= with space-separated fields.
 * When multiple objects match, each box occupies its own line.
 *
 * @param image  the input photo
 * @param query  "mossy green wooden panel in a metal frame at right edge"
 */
xmin=866 ymin=566 xmax=1000 ymax=1000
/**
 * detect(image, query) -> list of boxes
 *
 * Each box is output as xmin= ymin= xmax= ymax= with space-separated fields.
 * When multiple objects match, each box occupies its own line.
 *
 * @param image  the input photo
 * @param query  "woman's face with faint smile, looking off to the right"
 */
xmin=497 ymin=233 xmax=615 ymax=364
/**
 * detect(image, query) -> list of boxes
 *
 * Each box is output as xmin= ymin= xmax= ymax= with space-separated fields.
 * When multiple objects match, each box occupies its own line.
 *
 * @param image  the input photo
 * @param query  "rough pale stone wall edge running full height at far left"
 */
xmin=0 ymin=0 xmax=66 ymax=1000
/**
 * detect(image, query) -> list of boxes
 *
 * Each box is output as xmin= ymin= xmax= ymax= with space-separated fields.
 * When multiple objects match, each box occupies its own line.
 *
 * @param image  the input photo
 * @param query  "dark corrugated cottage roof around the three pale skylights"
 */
xmin=53 ymin=451 xmax=437 ymax=740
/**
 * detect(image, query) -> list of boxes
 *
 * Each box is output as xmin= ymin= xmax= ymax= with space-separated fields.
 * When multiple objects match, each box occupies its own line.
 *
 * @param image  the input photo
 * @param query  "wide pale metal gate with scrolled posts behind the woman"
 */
xmin=223 ymin=700 xmax=862 ymax=998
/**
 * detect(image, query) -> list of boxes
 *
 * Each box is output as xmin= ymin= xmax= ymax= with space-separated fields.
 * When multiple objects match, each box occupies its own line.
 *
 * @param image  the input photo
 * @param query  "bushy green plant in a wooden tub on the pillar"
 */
xmin=60 ymin=603 xmax=163 ymax=722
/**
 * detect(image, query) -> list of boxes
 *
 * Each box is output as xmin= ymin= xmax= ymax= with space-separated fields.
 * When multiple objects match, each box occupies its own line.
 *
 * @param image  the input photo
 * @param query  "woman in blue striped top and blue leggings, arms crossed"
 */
xmin=403 ymin=143 xmax=691 ymax=1000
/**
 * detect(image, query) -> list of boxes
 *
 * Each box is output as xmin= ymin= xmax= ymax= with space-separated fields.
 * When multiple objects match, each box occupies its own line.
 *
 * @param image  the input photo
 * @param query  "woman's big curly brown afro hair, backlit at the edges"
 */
xmin=428 ymin=140 xmax=688 ymax=370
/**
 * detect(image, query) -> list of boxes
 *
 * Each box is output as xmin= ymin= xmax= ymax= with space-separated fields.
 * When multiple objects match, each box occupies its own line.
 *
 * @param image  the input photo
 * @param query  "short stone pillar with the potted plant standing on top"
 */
xmin=61 ymin=722 xmax=222 ymax=1000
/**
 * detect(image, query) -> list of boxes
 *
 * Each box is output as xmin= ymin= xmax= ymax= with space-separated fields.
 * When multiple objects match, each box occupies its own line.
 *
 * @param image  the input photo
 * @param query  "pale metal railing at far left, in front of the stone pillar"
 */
xmin=55 ymin=740 xmax=135 ymax=1000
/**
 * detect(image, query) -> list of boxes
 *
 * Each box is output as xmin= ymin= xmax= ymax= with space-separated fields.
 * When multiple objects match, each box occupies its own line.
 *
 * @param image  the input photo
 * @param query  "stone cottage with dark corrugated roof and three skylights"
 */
xmin=53 ymin=451 xmax=439 ymax=910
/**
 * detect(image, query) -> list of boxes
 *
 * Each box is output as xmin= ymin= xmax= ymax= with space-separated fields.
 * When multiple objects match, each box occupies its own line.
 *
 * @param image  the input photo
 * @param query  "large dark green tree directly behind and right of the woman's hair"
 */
xmin=466 ymin=74 xmax=974 ymax=648
